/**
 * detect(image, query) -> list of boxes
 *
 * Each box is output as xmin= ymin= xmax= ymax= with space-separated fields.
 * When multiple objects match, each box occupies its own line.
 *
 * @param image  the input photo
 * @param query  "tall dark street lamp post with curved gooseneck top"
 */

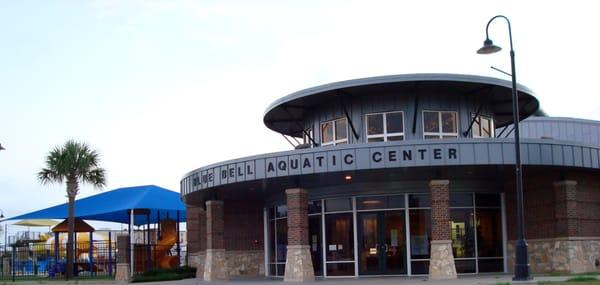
xmin=477 ymin=15 xmax=532 ymax=281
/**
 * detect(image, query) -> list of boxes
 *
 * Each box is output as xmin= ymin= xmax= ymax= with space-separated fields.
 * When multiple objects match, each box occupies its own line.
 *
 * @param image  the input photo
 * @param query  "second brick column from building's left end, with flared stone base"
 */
xmin=204 ymin=200 xmax=229 ymax=281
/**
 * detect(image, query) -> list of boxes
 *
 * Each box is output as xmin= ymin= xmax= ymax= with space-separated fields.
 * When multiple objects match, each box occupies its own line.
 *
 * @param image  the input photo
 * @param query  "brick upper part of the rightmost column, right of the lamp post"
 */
xmin=554 ymin=180 xmax=579 ymax=237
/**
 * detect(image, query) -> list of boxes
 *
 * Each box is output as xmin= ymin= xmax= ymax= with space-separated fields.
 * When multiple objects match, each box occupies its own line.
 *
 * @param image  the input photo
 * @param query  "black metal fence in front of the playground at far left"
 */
xmin=0 ymin=241 xmax=116 ymax=280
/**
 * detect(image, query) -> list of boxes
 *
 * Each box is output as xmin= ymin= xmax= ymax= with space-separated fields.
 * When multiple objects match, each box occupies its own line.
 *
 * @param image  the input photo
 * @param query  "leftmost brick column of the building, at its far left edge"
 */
xmin=186 ymin=205 xmax=206 ymax=278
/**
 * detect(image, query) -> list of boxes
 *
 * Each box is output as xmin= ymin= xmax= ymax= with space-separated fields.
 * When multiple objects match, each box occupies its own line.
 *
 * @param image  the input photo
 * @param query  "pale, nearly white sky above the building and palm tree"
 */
xmin=0 ymin=0 xmax=600 ymax=231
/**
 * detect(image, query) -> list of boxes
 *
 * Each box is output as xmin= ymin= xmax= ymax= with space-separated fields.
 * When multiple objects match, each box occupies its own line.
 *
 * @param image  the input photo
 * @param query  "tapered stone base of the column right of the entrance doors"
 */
xmin=429 ymin=240 xmax=456 ymax=280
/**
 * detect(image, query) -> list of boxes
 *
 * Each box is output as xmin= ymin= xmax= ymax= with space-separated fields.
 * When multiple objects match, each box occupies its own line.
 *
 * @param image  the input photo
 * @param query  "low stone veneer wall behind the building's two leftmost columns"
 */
xmin=188 ymin=250 xmax=265 ymax=277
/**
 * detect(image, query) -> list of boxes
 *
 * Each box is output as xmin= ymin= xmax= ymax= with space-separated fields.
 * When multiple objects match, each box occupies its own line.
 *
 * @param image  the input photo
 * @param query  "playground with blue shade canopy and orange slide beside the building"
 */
xmin=0 ymin=185 xmax=186 ymax=279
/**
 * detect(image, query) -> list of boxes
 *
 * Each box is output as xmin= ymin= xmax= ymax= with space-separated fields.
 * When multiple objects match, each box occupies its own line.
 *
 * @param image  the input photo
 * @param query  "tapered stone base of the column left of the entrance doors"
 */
xmin=283 ymin=245 xmax=315 ymax=282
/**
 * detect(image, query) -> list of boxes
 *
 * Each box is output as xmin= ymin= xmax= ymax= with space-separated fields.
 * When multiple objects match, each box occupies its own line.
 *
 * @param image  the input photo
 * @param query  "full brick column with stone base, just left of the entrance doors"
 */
xmin=283 ymin=188 xmax=315 ymax=282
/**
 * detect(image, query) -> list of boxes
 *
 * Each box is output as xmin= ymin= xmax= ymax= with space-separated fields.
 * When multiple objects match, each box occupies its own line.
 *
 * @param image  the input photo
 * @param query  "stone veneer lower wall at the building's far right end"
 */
xmin=507 ymin=237 xmax=600 ymax=273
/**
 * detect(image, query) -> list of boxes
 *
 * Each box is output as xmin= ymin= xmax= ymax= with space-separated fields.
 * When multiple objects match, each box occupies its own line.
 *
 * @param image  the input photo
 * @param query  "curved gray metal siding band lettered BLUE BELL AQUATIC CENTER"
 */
xmin=182 ymin=139 xmax=600 ymax=195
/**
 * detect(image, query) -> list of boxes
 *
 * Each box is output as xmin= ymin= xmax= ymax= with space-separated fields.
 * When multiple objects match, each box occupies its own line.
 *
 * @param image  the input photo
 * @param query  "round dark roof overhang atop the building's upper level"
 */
xmin=263 ymin=73 xmax=539 ymax=137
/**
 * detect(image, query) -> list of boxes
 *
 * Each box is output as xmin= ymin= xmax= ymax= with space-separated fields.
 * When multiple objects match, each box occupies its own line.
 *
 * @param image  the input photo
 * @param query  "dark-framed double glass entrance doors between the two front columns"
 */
xmin=358 ymin=211 xmax=407 ymax=275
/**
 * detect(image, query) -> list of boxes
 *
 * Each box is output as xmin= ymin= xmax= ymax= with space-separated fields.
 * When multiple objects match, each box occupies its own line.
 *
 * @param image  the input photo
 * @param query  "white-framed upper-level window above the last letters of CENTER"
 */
xmin=423 ymin=111 xmax=458 ymax=140
